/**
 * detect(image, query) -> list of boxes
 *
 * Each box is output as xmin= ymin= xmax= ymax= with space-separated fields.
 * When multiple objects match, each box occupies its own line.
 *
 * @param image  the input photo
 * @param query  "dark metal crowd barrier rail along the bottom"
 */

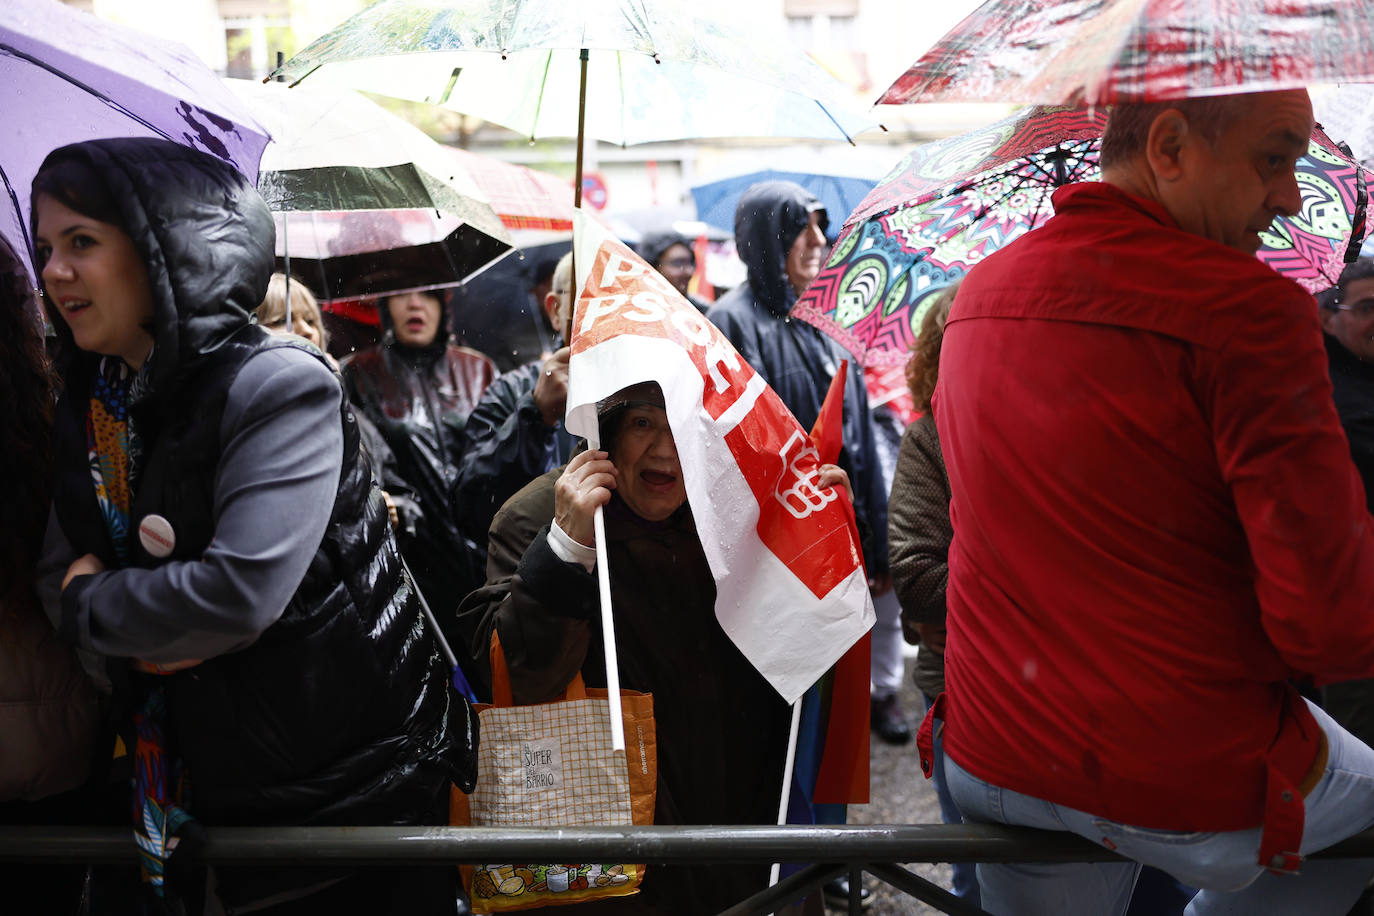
xmin=0 ymin=824 xmax=1374 ymax=916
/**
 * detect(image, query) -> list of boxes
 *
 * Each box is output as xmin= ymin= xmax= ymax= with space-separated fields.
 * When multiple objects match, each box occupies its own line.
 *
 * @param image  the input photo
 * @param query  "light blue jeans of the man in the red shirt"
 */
xmin=944 ymin=705 xmax=1374 ymax=916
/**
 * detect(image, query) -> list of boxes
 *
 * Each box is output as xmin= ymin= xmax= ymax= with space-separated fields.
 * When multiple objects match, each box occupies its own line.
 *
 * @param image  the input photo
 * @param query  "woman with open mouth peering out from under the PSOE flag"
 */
xmin=462 ymin=382 xmax=848 ymax=915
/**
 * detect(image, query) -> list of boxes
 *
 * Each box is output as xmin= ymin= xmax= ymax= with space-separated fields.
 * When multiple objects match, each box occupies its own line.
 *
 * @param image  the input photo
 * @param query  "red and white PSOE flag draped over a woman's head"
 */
xmin=567 ymin=213 xmax=874 ymax=703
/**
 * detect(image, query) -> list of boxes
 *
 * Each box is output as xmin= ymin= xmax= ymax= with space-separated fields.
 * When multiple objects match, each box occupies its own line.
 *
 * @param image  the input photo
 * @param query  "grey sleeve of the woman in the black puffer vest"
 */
xmin=60 ymin=347 xmax=344 ymax=665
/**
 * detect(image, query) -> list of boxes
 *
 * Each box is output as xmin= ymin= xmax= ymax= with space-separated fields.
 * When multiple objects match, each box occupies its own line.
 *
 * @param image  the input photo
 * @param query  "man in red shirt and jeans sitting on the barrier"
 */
xmin=923 ymin=91 xmax=1374 ymax=916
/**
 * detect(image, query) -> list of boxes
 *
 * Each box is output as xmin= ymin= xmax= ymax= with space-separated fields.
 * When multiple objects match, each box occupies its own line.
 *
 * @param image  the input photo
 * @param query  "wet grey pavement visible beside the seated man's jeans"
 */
xmin=829 ymin=656 xmax=949 ymax=916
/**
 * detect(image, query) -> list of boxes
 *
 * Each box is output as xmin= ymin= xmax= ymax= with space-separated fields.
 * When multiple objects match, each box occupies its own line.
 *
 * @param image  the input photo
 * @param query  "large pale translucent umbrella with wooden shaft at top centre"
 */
xmin=267 ymin=0 xmax=875 ymax=201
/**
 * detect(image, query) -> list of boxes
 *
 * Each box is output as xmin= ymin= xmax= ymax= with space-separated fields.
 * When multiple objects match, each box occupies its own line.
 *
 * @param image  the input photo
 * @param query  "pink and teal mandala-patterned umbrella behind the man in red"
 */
xmin=793 ymin=107 xmax=1367 ymax=365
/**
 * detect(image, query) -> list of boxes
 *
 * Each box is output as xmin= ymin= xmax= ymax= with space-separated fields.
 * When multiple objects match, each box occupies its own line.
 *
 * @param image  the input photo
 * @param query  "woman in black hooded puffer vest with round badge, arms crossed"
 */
xmin=33 ymin=139 xmax=475 ymax=913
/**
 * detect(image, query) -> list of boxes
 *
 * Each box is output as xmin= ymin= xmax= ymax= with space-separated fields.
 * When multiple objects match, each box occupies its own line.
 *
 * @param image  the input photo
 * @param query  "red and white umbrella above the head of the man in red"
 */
xmin=878 ymin=0 xmax=1374 ymax=104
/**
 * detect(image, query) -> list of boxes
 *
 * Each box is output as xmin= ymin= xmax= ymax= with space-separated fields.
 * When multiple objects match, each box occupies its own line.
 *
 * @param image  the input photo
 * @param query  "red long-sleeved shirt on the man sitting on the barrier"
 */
xmin=934 ymin=184 xmax=1374 ymax=851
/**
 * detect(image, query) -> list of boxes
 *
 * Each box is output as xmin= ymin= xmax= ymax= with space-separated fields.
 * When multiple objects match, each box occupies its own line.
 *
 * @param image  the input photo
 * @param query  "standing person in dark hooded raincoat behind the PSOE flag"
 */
xmin=706 ymin=181 xmax=910 ymax=905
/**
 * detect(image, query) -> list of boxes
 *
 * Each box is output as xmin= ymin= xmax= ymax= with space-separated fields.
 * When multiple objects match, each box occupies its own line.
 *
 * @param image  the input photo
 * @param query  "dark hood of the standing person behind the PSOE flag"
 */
xmin=735 ymin=181 xmax=830 ymax=314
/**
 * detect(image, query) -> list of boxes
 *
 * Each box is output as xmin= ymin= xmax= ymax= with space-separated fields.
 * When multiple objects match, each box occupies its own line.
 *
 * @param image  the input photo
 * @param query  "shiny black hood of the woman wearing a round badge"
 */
xmin=30 ymin=137 xmax=276 ymax=391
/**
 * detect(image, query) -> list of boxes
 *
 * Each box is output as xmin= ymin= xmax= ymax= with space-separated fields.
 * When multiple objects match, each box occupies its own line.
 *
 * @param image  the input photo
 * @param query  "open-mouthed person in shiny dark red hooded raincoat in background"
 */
xmin=342 ymin=290 xmax=496 ymax=637
